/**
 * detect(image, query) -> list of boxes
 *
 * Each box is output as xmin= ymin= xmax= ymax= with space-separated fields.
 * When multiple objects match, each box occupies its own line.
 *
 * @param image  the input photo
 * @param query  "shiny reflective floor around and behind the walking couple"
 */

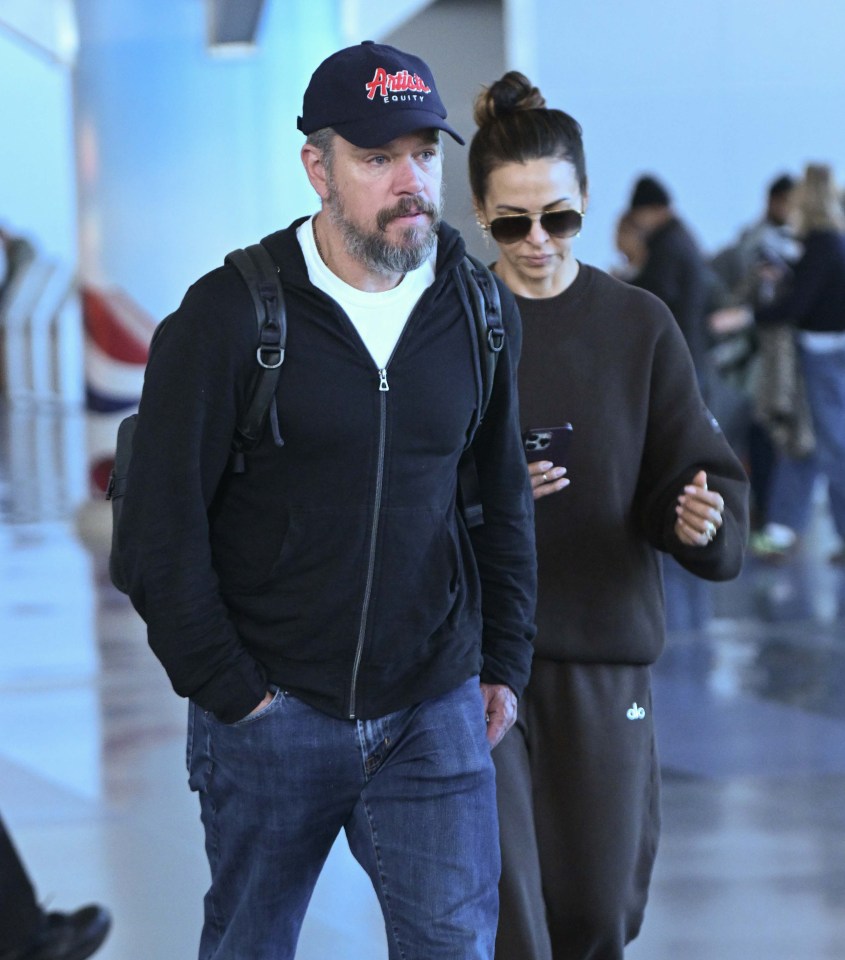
xmin=0 ymin=407 xmax=845 ymax=960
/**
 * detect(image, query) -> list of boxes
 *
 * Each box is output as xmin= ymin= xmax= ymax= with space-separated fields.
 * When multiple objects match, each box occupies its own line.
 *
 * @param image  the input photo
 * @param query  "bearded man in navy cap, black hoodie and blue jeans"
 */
xmin=120 ymin=42 xmax=535 ymax=960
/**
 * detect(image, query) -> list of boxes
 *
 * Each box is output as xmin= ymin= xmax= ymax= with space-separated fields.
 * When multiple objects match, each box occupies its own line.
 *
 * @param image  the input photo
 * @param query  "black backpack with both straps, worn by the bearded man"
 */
xmin=106 ymin=243 xmax=505 ymax=593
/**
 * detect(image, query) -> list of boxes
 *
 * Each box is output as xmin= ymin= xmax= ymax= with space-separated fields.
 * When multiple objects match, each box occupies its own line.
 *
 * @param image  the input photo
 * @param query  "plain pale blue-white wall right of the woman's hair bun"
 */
xmin=509 ymin=0 xmax=845 ymax=267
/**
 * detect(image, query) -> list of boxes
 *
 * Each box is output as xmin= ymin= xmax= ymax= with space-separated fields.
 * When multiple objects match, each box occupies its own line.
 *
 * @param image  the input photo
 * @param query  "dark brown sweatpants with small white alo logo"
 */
xmin=493 ymin=658 xmax=660 ymax=960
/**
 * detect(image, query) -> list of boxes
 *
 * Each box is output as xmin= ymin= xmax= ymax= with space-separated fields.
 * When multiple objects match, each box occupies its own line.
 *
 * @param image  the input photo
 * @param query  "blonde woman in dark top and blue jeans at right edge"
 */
xmin=713 ymin=164 xmax=845 ymax=563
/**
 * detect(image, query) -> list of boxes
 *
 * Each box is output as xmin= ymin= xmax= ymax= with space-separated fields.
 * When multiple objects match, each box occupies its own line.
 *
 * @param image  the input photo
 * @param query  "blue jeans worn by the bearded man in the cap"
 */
xmin=188 ymin=677 xmax=500 ymax=960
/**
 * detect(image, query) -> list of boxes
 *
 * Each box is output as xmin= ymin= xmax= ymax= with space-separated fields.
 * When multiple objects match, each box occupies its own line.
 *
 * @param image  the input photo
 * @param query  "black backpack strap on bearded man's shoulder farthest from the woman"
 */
xmin=225 ymin=243 xmax=287 ymax=464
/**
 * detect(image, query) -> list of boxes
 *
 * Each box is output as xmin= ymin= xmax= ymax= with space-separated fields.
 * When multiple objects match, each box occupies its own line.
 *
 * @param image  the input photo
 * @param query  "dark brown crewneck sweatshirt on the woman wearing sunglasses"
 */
xmin=517 ymin=265 xmax=748 ymax=664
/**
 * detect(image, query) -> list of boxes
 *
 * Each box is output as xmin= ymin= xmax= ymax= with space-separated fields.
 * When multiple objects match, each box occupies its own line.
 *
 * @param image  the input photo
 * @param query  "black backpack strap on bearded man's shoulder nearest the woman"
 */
xmin=458 ymin=254 xmax=505 ymax=527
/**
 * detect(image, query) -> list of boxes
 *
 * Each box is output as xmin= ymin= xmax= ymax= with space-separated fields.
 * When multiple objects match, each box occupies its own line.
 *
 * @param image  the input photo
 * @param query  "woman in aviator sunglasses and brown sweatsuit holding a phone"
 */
xmin=469 ymin=72 xmax=747 ymax=960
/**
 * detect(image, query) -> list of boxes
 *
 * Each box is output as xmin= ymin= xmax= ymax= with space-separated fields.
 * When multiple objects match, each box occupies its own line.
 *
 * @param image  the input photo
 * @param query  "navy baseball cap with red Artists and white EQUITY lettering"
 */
xmin=296 ymin=40 xmax=464 ymax=148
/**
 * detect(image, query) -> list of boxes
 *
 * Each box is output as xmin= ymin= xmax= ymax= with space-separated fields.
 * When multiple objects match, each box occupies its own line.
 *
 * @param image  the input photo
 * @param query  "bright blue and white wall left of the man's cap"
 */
xmin=76 ymin=0 xmax=340 ymax=318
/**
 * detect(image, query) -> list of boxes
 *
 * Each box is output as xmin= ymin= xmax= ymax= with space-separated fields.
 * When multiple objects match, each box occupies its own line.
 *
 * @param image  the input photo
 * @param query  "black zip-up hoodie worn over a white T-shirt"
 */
xmin=118 ymin=220 xmax=536 ymax=722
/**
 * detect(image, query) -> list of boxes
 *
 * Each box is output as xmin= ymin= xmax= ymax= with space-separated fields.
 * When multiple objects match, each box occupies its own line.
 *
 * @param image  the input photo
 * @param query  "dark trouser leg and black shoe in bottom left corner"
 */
xmin=0 ymin=819 xmax=111 ymax=960
